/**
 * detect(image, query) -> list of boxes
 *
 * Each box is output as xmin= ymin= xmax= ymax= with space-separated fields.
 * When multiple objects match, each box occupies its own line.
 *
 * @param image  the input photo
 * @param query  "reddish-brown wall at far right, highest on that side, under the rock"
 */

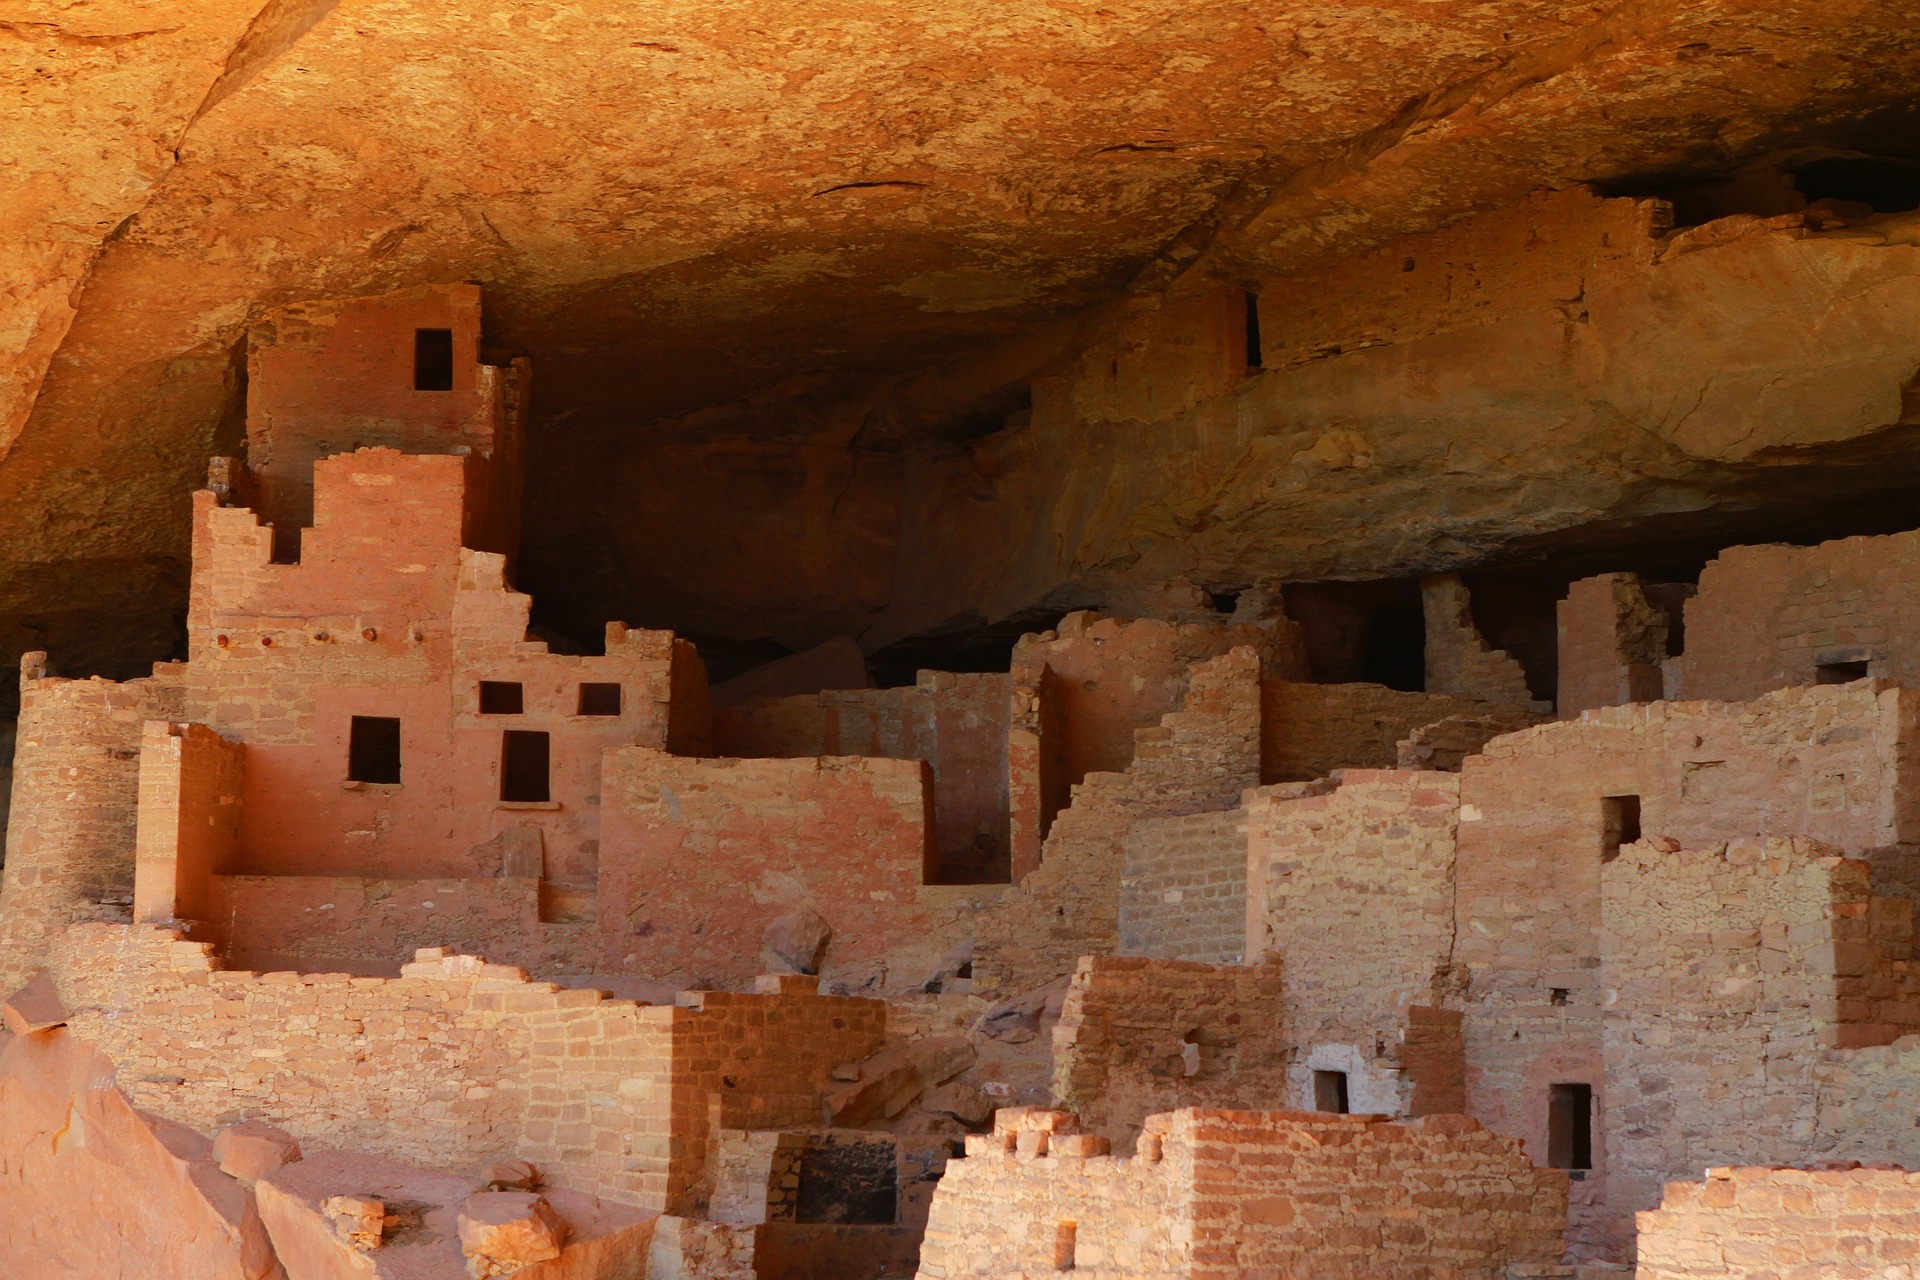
xmin=1680 ymin=532 xmax=1920 ymax=700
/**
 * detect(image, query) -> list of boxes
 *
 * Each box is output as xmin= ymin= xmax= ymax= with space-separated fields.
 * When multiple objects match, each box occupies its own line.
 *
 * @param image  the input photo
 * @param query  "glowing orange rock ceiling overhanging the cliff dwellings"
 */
xmin=0 ymin=0 xmax=1920 ymax=679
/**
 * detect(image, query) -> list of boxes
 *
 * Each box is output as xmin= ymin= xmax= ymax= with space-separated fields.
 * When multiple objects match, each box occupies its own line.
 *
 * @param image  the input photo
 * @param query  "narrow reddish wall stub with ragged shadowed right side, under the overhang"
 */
xmin=1555 ymin=574 xmax=1668 ymax=718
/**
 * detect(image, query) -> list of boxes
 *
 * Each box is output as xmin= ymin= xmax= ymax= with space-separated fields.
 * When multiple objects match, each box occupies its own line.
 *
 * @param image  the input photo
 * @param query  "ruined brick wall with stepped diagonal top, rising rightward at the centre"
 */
xmin=973 ymin=647 xmax=1260 ymax=996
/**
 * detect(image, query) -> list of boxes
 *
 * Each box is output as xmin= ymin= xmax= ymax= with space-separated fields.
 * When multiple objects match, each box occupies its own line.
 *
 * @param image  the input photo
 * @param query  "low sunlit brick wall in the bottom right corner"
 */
xmin=1634 ymin=1165 xmax=1920 ymax=1280
